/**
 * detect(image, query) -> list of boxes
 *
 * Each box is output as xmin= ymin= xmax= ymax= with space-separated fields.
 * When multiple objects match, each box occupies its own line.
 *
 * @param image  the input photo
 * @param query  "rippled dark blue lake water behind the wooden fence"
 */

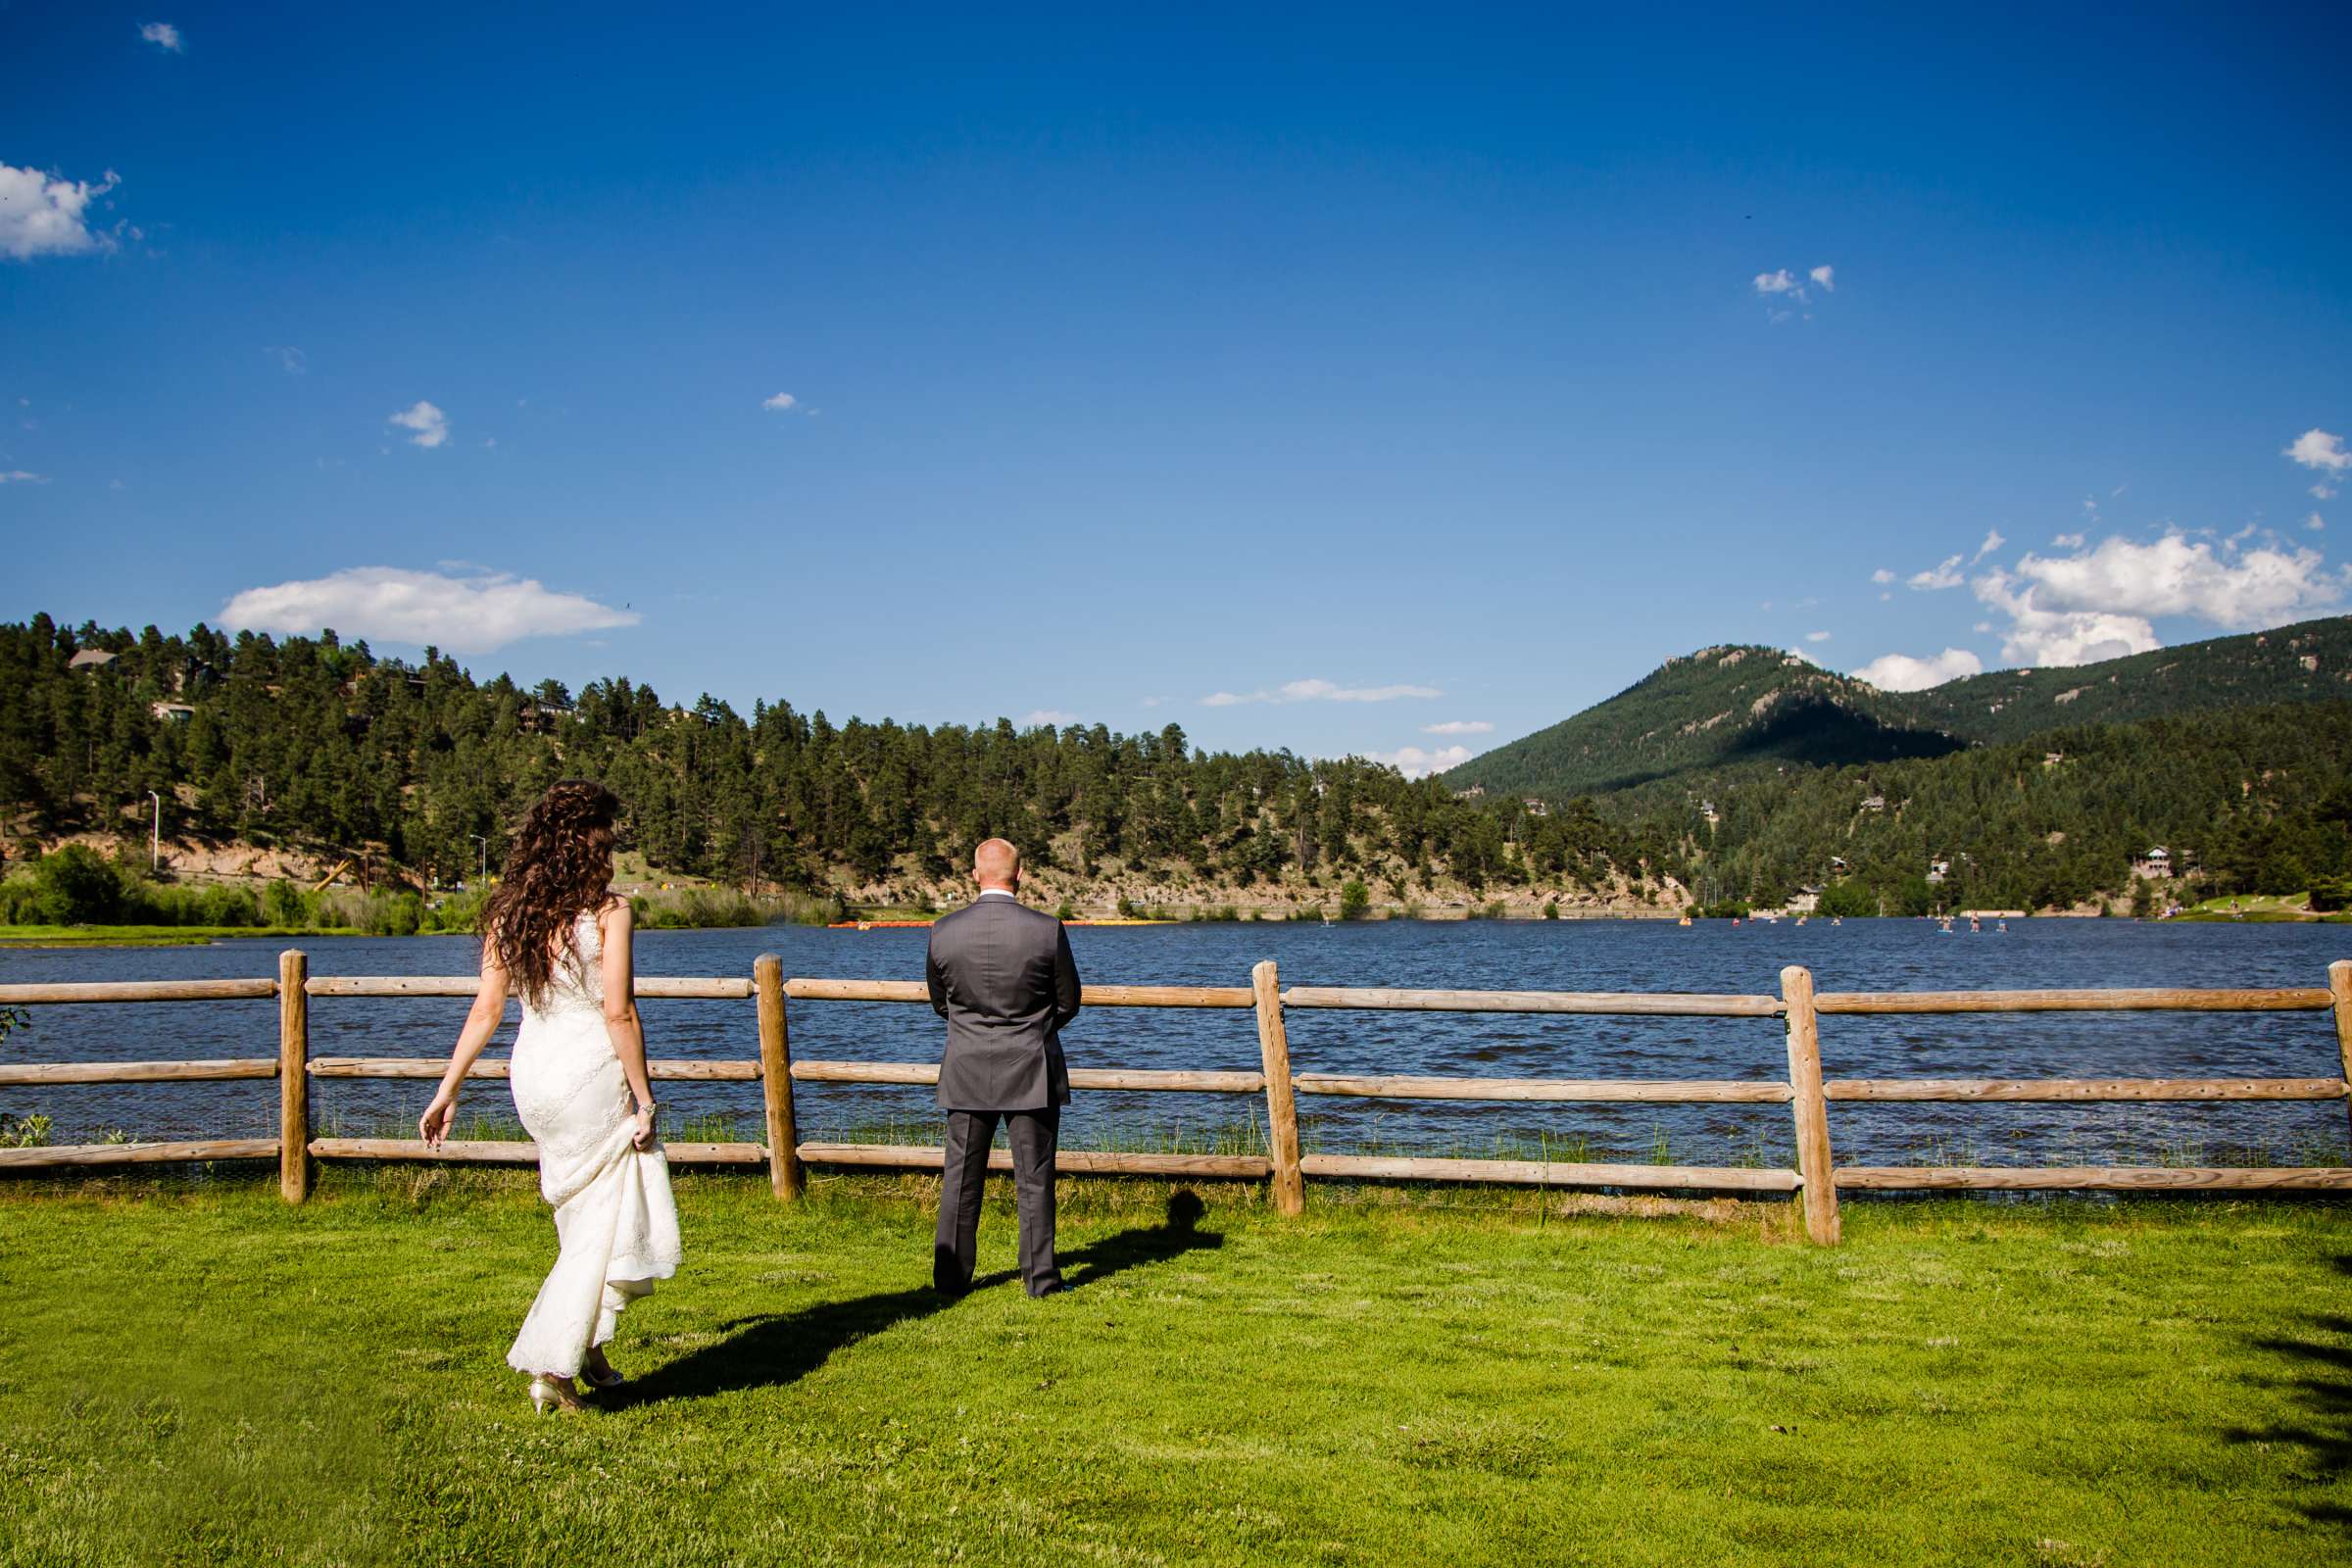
xmin=0 ymin=919 xmax=2352 ymax=1163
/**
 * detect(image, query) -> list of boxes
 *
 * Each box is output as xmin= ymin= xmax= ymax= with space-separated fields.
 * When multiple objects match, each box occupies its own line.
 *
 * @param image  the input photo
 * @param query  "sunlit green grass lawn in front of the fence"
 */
xmin=0 ymin=1168 xmax=2352 ymax=1568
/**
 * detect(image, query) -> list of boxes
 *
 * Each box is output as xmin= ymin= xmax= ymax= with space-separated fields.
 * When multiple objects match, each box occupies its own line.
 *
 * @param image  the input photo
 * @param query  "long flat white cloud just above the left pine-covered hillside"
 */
xmin=221 ymin=566 xmax=642 ymax=654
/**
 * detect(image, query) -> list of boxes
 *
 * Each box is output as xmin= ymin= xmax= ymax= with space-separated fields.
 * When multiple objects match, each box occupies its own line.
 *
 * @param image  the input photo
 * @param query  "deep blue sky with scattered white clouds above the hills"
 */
xmin=0 ymin=0 xmax=2352 ymax=766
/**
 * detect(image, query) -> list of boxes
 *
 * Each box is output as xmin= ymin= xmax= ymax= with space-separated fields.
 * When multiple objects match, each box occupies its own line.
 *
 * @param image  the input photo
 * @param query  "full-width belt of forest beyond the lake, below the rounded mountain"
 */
xmin=0 ymin=615 xmax=2352 ymax=931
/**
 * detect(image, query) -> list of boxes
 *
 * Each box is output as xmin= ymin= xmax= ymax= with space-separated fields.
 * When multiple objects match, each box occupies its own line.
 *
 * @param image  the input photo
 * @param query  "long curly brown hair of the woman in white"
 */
xmin=482 ymin=778 xmax=621 ymax=1006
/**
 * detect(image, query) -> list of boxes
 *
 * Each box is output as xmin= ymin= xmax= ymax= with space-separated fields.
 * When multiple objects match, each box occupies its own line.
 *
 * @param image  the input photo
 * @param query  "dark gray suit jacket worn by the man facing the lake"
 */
xmin=924 ymin=898 xmax=1077 ymax=1109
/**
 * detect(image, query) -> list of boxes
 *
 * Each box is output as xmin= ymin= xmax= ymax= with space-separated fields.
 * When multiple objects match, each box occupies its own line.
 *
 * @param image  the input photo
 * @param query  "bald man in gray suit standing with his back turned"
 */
xmin=924 ymin=839 xmax=1077 ymax=1296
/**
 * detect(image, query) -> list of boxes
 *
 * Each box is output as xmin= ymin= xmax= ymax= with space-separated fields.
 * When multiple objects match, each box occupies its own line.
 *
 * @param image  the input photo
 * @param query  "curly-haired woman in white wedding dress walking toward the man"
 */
xmin=416 ymin=778 xmax=680 ymax=1413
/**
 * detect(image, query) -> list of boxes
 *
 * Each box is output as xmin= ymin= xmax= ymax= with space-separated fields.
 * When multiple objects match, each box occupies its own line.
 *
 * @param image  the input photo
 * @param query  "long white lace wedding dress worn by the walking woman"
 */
xmin=506 ymin=914 xmax=680 ymax=1375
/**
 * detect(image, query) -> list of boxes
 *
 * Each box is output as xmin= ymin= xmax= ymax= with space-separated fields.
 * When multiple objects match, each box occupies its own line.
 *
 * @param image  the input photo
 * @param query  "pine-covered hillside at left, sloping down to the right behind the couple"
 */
xmin=0 ymin=618 xmax=1665 ymax=901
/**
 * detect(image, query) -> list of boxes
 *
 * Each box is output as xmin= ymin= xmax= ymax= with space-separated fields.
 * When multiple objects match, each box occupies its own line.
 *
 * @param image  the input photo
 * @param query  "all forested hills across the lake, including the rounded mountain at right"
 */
xmin=0 ymin=618 xmax=2352 ymax=912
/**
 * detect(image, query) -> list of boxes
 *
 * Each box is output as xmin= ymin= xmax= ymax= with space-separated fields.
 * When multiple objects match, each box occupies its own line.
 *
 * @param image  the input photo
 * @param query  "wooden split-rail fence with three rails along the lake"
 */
xmin=0 ymin=953 xmax=2352 ymax=1244
